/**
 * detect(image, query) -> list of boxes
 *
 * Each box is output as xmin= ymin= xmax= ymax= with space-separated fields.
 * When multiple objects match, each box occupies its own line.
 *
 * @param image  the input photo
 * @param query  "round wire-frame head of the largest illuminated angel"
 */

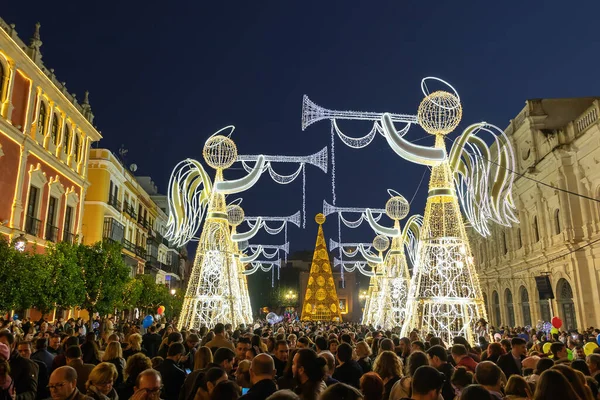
xmin=417 ymin=90 xmax=462 ymax=135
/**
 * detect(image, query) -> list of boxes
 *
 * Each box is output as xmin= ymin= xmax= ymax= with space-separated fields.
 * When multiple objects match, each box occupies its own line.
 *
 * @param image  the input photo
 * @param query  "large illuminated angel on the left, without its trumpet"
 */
xmin=166 ymin=126 xmax=264 ymax=329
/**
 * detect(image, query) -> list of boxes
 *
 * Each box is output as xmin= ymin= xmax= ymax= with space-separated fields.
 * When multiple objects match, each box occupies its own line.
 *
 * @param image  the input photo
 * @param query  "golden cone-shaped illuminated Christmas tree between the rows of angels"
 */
xmin=302 ymin=213 xmax=342 ymax=321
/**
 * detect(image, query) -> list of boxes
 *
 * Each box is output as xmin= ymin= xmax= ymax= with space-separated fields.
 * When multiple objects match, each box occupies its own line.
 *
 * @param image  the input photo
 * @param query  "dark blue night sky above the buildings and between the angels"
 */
xmin=0 ymin=0 xmax=600 ymax=253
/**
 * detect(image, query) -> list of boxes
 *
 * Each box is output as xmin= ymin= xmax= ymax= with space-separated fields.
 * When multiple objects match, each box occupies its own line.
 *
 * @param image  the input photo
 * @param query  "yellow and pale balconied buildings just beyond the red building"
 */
xmin=81 ymin=149 xmax=181 ymax=286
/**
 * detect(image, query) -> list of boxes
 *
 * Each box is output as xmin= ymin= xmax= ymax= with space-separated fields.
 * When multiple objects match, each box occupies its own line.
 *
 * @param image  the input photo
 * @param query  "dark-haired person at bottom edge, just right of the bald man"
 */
xmin=292 ymin=349 xmax=326 ymax=400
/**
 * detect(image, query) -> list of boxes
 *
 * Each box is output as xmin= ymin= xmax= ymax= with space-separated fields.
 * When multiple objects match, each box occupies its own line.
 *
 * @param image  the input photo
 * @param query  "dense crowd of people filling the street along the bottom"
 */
xmin=0 ymin=318 xmax=600 ymax=400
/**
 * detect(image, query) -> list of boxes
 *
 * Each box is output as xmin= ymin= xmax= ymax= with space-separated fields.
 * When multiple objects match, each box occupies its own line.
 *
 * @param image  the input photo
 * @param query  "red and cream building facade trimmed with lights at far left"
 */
xmin=0 ymin=19 xmax=101 ymax=252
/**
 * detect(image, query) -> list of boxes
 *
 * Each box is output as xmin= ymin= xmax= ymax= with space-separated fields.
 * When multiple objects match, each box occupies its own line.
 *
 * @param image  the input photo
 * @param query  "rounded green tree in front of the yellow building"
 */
xmin=77 ymin=241 xmax=130 ymax=323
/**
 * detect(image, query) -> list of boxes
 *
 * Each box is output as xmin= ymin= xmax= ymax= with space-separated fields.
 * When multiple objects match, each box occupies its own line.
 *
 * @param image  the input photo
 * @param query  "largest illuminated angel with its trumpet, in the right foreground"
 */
xmin=303 ymin=77 xmax=518 ymax=342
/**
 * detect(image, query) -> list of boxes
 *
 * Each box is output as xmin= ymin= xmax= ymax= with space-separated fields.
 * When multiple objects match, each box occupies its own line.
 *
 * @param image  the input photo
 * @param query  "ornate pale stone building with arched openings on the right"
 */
xmin=470 ymin=98 xmax=600 ymax=329
